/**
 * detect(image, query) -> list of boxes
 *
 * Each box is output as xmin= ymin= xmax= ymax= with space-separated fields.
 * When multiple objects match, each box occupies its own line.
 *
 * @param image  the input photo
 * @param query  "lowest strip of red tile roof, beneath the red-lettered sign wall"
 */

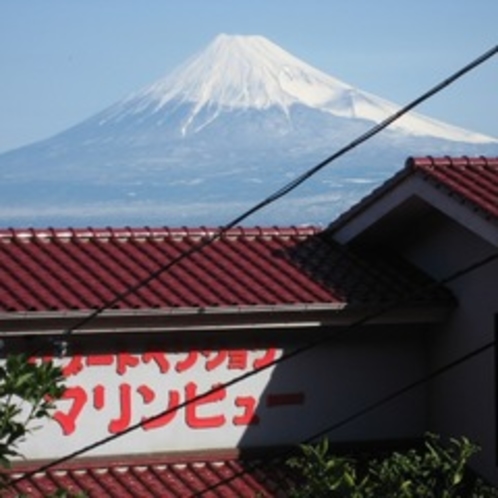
xmin=2 ymin=456 xmax=290 ymax=498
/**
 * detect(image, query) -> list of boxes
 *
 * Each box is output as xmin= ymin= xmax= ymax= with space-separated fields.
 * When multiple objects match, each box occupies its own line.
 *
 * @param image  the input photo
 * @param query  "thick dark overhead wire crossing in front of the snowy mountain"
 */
xmin=58 ymin=45 xmax=498 ymax=336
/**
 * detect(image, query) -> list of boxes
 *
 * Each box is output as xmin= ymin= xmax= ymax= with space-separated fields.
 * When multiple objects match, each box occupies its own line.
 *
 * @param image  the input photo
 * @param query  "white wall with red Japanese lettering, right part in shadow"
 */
xmin=15 ymin=325 xmax=427 ymax=459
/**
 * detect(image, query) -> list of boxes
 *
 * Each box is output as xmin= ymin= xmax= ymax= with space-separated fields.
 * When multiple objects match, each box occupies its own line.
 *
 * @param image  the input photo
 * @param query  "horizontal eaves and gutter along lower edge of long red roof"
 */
xmin=0 ymin=302 xmax=453 ymax=337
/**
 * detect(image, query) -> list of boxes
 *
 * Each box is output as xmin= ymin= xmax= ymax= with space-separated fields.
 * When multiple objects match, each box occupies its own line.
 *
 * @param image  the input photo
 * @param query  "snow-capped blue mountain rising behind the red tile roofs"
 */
xmin=0 ymin=35 xmax=498 ymax=227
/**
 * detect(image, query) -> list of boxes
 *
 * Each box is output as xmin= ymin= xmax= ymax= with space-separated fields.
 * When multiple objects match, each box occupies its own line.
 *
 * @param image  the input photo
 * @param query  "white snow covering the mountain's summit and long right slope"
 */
xmin=101 ymin=34 xmax=494 ymax=143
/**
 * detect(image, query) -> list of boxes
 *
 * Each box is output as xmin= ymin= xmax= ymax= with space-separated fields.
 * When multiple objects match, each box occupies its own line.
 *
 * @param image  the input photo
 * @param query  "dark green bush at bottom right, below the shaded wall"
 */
xmin=288 ymin=434 xmax=498 ymax=498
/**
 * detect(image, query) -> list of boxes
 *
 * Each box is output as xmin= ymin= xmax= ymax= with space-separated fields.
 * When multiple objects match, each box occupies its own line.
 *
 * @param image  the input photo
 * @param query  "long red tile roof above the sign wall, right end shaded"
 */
xmin=0 ymin=228 xmax=448 ymax=312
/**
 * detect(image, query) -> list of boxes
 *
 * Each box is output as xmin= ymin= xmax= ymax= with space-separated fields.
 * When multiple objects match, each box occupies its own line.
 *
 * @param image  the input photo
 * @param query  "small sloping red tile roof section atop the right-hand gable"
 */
xmin=406 ymin=157 xmax=498 ymax=218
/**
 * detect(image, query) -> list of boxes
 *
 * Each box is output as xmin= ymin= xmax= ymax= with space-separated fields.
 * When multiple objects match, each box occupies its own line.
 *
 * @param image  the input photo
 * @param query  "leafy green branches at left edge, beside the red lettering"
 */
xmin=0 ymin=355 xmax=65 ymax=468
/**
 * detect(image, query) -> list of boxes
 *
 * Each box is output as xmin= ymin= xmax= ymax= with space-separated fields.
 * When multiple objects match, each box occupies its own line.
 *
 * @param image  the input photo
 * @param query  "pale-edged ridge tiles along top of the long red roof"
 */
xmin=0 ymin=225 xmax=323 ymax=242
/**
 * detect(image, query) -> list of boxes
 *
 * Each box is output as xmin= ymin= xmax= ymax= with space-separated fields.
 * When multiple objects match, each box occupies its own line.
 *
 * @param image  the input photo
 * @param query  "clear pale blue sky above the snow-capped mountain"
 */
xmin=0 ymin=0 xmax=498 ymax=152
